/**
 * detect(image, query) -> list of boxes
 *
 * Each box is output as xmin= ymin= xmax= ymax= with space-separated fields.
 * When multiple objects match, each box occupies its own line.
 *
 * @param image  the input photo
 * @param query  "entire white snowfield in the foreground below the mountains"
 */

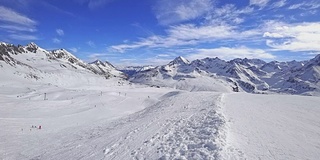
xmin=0 ymin=82 xmax=320 ymax=160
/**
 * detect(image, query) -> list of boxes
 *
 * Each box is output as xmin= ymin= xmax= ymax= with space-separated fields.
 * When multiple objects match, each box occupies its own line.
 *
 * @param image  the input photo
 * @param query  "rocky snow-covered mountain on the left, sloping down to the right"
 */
xmin=0 ymin=43 xmax=127 ymax=86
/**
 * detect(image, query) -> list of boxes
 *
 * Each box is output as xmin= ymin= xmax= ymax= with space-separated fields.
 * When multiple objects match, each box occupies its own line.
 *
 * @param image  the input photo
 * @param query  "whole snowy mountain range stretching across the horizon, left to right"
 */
xmin=0 ymin=42 xmax=320 ymax=95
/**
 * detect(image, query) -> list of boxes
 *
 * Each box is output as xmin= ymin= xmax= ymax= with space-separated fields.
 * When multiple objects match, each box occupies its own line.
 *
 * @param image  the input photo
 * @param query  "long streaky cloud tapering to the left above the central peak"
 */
xmin=109 ymin=24 xmax=261 ymax=53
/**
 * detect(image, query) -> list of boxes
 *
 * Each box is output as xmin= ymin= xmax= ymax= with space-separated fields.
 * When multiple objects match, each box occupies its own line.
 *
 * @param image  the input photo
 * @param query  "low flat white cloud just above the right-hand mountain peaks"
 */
xmin=186 ymin=46 xmax=275 ymax=60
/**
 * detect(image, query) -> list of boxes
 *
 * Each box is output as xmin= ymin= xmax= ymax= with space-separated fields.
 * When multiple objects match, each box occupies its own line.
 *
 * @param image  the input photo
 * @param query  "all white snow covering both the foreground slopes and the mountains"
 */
xmin=0 ymin=43 xmax=320 ymax=160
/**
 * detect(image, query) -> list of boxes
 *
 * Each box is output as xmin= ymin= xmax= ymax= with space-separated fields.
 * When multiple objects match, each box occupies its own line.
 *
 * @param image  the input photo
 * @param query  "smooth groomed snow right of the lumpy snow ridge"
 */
xmin=223 ymin=93 xmax=320 ymax=160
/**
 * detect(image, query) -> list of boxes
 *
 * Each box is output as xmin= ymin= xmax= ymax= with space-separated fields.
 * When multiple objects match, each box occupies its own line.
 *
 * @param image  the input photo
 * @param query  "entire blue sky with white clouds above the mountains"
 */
xmin=0 ymin=0 xmax=320 ymax=65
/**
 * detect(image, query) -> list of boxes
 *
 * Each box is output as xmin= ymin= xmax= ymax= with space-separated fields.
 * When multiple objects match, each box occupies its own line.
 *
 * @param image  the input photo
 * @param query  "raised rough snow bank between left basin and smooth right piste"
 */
xmin=24 ymin=92 xmax=230 ymax=160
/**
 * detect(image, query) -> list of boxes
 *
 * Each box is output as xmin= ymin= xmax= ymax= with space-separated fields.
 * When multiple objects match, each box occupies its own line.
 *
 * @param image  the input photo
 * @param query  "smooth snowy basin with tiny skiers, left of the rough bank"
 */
xmin=0 ymin=82 xmax=175 ymax=159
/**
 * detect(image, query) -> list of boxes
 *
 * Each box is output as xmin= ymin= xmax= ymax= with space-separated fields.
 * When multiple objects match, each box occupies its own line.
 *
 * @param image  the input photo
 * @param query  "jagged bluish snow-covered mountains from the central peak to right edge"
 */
xmin=130 ymin=55 xmax=320 ymax=95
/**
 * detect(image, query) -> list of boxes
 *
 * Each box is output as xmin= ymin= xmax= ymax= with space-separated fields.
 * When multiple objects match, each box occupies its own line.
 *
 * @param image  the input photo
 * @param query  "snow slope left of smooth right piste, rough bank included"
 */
xmin=0 ymin=85 xmax=228 ymax=159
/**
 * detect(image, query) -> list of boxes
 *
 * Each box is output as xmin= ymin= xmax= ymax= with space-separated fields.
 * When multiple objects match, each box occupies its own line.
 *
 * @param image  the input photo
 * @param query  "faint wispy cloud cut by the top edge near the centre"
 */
xmin=154 ymin=0 xmax=213 ymax=25
